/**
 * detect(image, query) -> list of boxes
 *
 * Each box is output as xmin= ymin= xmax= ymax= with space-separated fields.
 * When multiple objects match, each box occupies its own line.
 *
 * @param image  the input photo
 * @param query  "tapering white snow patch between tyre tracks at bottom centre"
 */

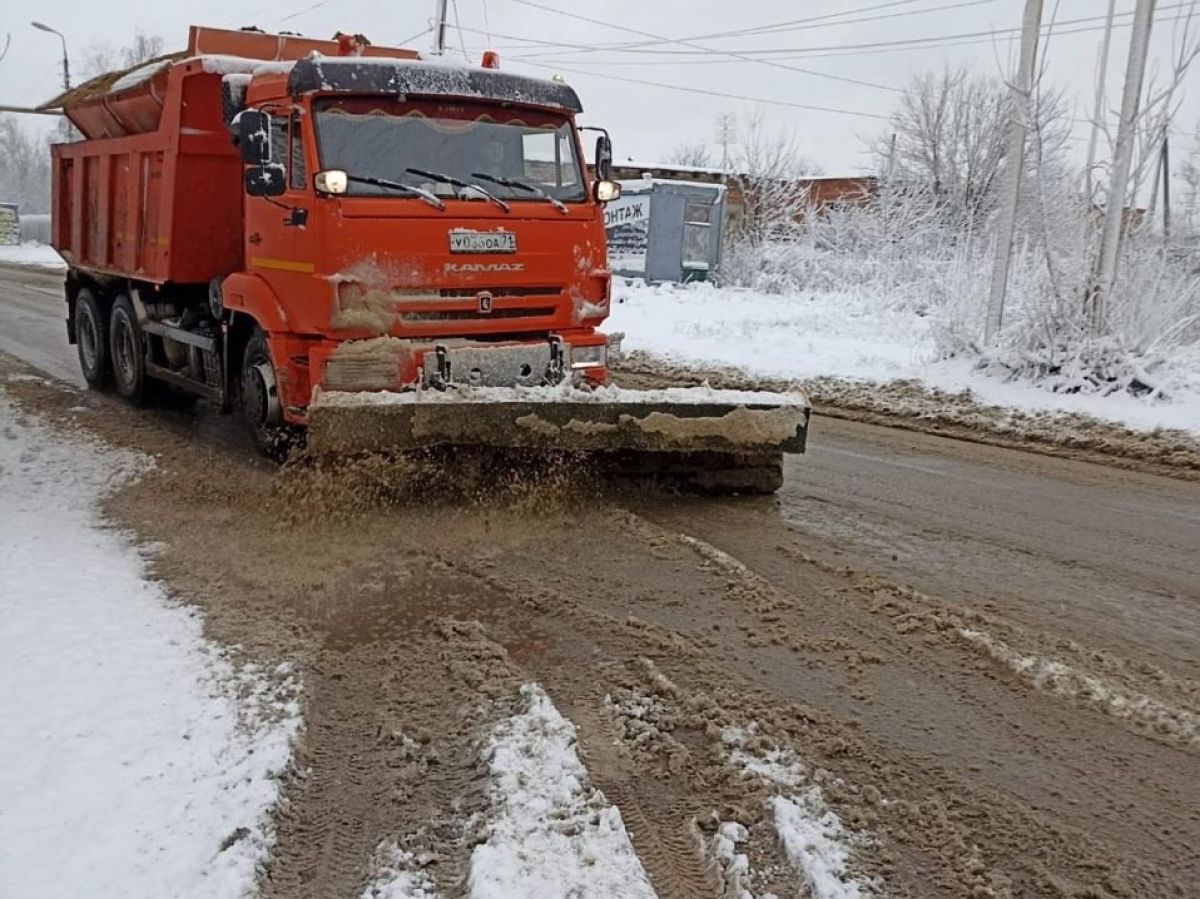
xmin=468 ymin=684 xmax=654 ymax=899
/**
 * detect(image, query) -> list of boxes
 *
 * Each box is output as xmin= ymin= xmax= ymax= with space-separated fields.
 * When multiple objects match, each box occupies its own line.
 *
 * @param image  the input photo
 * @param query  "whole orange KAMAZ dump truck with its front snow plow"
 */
xmin=48 ymin=28 xmax=809 ymax=489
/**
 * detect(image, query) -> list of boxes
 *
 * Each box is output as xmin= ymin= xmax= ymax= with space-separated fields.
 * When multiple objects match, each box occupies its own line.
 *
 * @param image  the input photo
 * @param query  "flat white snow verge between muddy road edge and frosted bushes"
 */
xmin=606 ymin=278 xmax=1200 ymax=434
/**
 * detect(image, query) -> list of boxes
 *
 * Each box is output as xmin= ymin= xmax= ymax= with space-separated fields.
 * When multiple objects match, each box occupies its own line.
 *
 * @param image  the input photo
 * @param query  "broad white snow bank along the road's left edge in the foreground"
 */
xmin=0 ymin=392 xmax=299 ymax=899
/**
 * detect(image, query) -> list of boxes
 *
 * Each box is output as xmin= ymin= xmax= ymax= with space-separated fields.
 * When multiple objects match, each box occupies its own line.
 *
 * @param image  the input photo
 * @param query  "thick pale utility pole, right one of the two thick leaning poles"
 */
xmin=1088 ymin=0 xmax=1154 ymax=330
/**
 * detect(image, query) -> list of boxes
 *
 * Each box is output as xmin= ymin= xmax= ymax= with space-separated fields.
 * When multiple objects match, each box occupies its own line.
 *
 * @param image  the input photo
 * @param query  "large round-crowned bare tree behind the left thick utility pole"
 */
xmin=870 ymin=68 xmax=1066 ymax=228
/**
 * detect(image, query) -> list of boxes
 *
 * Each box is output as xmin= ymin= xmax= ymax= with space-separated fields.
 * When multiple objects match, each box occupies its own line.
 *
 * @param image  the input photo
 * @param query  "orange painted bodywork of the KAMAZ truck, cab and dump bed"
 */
xmin=53 ymin=28 xmax=611 ymax=425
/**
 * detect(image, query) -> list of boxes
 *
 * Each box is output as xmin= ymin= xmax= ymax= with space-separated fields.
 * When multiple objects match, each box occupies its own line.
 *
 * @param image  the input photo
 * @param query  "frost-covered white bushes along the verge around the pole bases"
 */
xmin=722 ymin=169 xmax=1200 ymax=392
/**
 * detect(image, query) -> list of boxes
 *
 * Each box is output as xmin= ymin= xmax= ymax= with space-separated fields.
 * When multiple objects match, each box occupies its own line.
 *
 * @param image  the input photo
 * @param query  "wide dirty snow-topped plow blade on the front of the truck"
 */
xmin=308 ymin=386 xmax=810 ymax=492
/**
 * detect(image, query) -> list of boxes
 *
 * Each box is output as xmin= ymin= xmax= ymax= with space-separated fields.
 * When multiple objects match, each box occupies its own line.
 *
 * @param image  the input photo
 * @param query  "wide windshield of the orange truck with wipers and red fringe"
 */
xmin=314 ymin=97 xmax=587 ymax=202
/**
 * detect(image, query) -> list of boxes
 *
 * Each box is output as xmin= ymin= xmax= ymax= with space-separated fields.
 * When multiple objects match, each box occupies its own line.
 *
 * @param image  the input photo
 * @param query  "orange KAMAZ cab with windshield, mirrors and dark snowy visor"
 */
xmin=220 ymin=58 xmax=616 ymax=434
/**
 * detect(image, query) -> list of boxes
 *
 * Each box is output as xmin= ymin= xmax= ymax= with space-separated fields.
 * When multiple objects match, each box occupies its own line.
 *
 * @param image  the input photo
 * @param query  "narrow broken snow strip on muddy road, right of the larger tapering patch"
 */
xmin=721 ymin=725 xmax=875 ymax=899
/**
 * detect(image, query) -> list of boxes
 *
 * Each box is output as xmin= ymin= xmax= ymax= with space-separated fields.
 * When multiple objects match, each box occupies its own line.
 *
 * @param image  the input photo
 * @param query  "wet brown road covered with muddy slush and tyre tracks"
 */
xmin=0 ymin=262 xmax=1200 ymax=899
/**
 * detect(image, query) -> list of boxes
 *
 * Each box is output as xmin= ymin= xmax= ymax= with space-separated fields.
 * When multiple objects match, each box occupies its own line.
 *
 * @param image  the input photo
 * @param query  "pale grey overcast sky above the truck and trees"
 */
xmin=0 ymin=0 xmax=1200 ymax=174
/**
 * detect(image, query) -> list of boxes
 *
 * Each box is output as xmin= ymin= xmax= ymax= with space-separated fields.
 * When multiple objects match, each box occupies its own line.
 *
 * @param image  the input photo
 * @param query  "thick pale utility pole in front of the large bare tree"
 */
xmin=984 ymin=0 xmax=1042 ymax=343
